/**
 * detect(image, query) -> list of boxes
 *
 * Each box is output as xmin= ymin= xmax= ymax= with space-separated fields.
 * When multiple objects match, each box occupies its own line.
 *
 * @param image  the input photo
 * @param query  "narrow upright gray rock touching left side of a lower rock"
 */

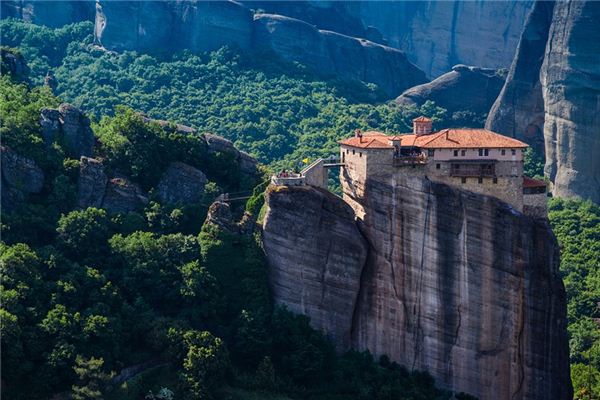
xmin=77 ymin=157 xmax=108 ymax=208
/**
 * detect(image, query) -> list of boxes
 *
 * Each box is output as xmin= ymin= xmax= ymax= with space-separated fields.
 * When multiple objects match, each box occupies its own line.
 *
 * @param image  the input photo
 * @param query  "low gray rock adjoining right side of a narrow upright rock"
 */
xmin=102 ymin=176 xmax=148 ymax=214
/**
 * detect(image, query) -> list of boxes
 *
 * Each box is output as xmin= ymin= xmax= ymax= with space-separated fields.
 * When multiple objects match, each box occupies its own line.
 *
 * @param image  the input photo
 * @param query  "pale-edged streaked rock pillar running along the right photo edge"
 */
xmin=540 ymin=1 xmax=600 ymax=203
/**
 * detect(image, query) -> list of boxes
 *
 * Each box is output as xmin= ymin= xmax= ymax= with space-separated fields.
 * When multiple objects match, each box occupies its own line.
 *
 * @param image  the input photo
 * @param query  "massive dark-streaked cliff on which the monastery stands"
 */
xmin=263 ymin=175 xmax=572 ymax=399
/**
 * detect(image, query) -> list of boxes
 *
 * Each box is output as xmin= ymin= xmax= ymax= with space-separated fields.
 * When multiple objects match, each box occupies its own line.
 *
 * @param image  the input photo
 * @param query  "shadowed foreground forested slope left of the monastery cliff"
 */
xmin=0 ymin=57 xmax=450 ymax=399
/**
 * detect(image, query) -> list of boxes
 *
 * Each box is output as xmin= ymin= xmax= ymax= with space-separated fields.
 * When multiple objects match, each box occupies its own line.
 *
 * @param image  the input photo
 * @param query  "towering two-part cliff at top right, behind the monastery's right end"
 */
xmin=486 ymin=1 xmax=600 ymax=202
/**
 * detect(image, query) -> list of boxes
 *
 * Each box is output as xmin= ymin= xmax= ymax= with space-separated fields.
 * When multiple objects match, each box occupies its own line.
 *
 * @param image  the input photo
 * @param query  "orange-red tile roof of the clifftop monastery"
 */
xmin=339 ymin=129 xmax=527 ymax=149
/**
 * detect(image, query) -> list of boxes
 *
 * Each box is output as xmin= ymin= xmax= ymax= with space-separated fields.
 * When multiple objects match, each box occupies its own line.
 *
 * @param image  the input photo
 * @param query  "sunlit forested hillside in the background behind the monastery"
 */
xmin=0 ymin=20 xmax=485 ymax=170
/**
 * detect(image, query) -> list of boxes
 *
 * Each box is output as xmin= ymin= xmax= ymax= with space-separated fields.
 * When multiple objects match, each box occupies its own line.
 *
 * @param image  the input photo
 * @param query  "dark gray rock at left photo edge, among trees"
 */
xmin=0 ymin=146 xmax=44 ymax=211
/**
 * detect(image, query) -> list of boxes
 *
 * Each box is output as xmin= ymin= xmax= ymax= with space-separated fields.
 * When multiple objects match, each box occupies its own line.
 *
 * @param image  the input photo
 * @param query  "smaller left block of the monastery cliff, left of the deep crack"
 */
xmin=263 ymin=186 xmax=367 ymax=350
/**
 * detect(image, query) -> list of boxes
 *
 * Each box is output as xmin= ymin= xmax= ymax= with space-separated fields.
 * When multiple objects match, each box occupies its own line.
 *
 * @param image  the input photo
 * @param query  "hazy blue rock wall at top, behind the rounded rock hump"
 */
xmin=243 ymin=1 xmax=533 ymax=77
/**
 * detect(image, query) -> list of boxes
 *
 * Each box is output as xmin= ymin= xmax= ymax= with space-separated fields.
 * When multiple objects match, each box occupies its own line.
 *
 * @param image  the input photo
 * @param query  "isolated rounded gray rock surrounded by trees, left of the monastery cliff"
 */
xmin=158 ymin=162 xmax=207 ymax=204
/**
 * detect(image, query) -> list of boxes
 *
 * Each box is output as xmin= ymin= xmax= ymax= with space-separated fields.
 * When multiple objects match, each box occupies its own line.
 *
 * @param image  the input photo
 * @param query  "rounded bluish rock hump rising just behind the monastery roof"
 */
xmin=396 ymin=65 xmax=504 ymax=114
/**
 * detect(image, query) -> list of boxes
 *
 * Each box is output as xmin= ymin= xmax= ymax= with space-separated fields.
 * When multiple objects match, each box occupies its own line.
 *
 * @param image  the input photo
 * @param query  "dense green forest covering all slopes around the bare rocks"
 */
xmin=0 ymin=16 xmax=600 ymax=399
